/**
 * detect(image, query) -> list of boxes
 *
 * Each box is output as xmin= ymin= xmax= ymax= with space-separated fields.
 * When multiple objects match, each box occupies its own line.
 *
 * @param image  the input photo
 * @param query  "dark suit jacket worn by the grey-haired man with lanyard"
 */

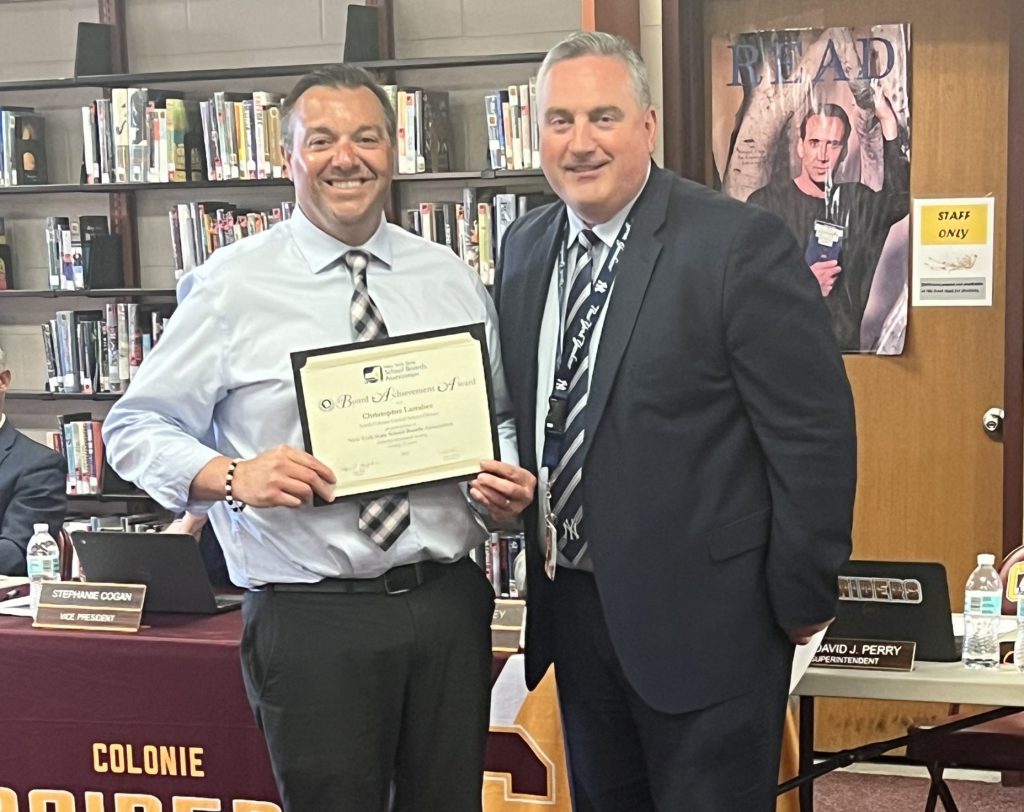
xmin=496 ymin=167 xmax=856 ymax=713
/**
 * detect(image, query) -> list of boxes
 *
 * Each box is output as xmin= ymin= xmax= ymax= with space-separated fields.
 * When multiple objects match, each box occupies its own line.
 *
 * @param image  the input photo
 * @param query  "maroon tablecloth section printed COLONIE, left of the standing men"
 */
xmin=0 ymin=611 xmax=279 ymax=812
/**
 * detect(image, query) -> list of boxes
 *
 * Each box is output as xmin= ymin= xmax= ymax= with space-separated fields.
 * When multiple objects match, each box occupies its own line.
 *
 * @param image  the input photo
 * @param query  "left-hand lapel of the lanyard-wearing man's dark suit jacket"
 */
xmin=516 ymin=206 xmax=565 ymax=470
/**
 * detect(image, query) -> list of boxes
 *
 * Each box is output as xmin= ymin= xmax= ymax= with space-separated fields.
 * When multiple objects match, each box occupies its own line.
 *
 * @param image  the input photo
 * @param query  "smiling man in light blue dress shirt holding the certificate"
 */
xmin=103 ymin=66 xmax=535 ymax=812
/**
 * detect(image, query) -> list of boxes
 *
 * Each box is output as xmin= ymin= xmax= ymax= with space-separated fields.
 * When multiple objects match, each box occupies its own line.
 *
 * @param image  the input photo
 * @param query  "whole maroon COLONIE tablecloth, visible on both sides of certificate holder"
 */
xmin=0 ymin=611 xmax=568 ymax=812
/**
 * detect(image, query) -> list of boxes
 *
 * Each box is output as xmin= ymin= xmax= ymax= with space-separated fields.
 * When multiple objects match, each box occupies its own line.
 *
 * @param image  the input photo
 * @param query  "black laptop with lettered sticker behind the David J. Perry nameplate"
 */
xmin=825 ymin=561 xmax=963 ymax=663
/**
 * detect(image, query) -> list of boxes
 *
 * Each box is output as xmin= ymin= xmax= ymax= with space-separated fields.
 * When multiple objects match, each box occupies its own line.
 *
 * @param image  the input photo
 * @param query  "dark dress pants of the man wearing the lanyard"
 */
xmin=550 ymin=569 xmax=792 ymax=812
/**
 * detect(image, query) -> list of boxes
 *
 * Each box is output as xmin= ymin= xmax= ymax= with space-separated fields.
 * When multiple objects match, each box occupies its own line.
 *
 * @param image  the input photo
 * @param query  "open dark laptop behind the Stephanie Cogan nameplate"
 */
xmin=72 ymin=530 xmax=242 ymax=614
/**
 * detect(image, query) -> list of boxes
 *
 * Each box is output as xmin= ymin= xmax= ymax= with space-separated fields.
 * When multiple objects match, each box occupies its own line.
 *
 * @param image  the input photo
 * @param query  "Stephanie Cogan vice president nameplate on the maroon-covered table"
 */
xmin=32 ymin=581 xmax=145 ymax=632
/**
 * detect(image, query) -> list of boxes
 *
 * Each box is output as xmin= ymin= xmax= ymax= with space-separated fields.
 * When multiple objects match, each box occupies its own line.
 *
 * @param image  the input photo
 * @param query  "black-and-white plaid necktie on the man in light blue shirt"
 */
xmin=342 ymin=251 xmax=409 ymax=550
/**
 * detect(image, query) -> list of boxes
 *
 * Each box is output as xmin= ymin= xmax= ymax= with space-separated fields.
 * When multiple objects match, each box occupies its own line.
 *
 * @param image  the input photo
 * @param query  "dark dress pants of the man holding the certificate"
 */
xmin=242 ymin=559 xmax=495 ymax=812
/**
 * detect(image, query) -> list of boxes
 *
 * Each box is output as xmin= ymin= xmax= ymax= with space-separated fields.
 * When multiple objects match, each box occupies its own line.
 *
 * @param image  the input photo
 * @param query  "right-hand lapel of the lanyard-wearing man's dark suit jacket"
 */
xmin=584 ymin=167 xmax=673 ymax=452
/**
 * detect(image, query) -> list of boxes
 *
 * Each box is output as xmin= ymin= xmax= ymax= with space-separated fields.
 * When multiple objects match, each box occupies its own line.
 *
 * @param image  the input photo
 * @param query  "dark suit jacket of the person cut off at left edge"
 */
xmin=0 ymin=420 xmax=68 ymax=575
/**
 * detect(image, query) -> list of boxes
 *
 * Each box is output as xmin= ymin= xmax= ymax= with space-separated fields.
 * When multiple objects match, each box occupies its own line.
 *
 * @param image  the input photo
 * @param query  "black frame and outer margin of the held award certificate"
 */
xmin=291 ymin=323 xmax=500 ymax=505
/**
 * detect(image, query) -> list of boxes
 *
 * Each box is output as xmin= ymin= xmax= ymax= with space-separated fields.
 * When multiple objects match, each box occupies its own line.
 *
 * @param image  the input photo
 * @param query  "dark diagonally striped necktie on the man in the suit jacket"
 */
xmin=550 ymin=230 xmax=598 ymax=563
